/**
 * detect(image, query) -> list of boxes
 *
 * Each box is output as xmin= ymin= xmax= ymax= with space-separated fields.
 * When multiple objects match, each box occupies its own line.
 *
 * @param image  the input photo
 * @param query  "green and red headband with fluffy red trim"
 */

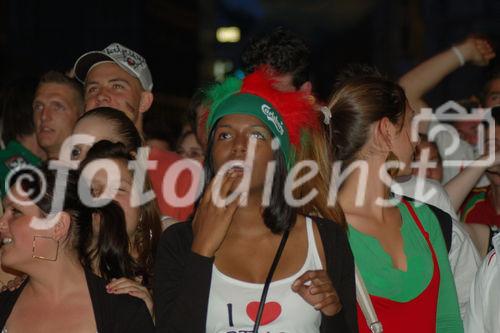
xmin=207 ymin=67 xmax=319 ymax=169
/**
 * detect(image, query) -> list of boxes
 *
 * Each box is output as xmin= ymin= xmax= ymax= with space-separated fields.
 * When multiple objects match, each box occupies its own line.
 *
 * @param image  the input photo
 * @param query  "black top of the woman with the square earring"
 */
xmin=0 ymin=270 xmax=154 ymax=333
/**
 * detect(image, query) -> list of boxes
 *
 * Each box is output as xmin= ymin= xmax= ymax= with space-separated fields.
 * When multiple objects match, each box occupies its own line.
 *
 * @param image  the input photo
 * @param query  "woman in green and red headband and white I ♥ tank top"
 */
xmin=154 ymin=69 xmax=357 ymax=332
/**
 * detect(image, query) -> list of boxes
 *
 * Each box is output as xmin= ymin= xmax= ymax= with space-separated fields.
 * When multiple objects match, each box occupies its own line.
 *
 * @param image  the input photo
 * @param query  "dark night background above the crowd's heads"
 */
xmin=0 ymin=0 xmax=500 ymax=124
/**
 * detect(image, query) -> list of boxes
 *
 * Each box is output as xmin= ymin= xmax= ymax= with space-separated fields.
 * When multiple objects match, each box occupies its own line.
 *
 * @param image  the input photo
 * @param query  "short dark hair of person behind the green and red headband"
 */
xmin=241 ymin=27 xmax=311 ymax=89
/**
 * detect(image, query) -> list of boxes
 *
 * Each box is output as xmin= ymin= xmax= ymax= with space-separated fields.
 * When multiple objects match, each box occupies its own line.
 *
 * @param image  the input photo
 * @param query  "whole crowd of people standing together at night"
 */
xmin=0 ymin=28 xmax=500 ymax=333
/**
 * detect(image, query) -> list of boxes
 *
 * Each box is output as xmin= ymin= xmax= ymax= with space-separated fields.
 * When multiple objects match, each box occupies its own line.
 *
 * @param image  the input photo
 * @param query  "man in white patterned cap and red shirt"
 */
xmin=73 ymin=43 xmax=198 ymax=221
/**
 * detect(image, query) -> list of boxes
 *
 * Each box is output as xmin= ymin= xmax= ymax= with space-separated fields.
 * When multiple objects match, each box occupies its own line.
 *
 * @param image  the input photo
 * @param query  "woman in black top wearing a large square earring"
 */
xmin=0 ymin=170 xmax=154 ymax=333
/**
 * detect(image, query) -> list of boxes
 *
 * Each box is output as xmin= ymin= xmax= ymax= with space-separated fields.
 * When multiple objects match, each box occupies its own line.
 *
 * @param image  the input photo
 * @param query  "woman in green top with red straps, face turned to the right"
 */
xmin=327 ymin=67 xmax=464 ymax=333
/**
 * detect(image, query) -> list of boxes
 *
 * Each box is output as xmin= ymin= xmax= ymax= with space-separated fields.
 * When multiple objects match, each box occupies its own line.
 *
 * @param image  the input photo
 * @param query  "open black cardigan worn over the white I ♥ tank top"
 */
xmin=153 ymin=218 xmax=358 ymax=333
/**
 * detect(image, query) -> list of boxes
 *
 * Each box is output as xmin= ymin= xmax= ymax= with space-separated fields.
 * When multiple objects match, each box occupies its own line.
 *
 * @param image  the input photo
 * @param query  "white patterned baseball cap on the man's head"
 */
xmin=73 ymin=43 xmax=153 ymax=91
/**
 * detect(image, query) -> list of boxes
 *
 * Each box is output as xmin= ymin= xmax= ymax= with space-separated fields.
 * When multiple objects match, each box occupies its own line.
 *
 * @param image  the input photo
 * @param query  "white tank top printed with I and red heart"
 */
xmin=206 ymin=218 xmax=323 ymax=333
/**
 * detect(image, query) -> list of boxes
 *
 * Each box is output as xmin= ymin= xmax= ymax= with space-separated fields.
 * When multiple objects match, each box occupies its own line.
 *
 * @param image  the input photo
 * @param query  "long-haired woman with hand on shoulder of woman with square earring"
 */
xmin=80 ymin=140 xmax=162 ymax=315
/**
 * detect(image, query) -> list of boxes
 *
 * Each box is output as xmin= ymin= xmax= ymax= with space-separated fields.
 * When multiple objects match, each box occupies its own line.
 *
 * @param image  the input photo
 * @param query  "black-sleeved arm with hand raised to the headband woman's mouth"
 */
xmin=153 ymin=172 xmax=242 ymax=332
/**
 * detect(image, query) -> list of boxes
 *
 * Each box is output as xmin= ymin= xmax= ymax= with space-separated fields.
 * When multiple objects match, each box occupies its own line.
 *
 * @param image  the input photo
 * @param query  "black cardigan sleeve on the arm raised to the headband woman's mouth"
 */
xmin=153 ymin=222 xmax=213 ymax=333
